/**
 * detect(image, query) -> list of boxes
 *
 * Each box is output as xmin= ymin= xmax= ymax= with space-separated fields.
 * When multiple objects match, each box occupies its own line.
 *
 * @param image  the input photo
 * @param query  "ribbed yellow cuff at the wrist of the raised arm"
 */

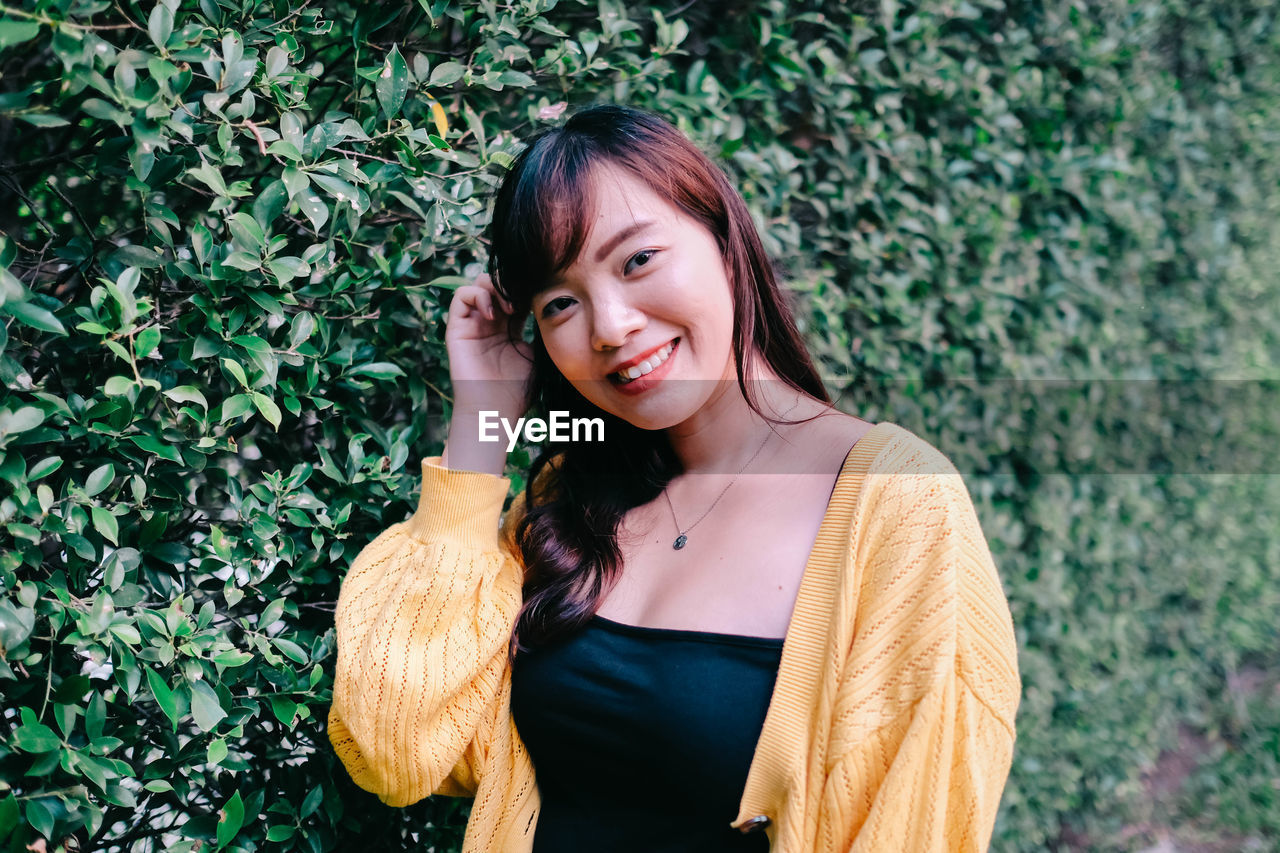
xmin=407 ymin=456 xmax=511 ymax=551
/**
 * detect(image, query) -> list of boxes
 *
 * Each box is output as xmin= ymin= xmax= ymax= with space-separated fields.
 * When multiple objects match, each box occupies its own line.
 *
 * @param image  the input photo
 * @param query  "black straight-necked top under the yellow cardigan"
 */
xmin=511 ymin=616 xmax=782 ymax=853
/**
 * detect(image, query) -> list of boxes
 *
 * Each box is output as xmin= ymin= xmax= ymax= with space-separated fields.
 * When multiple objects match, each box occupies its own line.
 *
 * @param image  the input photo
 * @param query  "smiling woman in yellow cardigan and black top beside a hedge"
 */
xmin=329 ymin=106 xmax=1019 ymax=853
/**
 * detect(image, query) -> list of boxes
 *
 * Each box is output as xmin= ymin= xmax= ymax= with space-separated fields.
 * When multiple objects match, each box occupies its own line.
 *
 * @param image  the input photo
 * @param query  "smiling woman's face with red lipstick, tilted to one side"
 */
xmin=532 ymin=167 xmax=736 ymax=429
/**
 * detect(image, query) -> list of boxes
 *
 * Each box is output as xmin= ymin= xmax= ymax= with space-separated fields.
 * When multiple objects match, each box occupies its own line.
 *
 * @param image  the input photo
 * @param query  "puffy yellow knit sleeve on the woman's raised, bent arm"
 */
xmin=329 ymin=459 xmax=522 ymax=806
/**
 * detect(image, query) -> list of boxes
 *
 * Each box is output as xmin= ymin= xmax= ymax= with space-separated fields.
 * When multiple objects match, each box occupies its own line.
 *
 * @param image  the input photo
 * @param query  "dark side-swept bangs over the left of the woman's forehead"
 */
xmin=489 ymin=132 xmax=599 ymax=310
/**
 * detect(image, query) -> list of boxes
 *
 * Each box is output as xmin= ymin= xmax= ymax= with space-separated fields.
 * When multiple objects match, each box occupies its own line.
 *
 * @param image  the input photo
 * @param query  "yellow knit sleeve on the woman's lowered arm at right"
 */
xmin=819 ymin=442 xmax=1020 ymax=853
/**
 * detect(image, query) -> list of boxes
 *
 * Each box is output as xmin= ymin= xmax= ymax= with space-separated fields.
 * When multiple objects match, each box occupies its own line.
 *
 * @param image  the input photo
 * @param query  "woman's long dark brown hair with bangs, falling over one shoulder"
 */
xmin=489 ymin=105 xmax=829 ymax=654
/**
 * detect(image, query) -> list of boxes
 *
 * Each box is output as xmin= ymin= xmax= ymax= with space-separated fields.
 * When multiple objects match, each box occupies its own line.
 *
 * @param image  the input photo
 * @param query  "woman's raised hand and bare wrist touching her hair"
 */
xmin=444 ymin=275 xmax=532 ymax=474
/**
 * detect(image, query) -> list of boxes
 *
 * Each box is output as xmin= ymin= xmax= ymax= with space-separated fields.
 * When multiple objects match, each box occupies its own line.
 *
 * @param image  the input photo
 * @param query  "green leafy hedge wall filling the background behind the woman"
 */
xmin=0 ymin=0 xmax=1280 ymax=853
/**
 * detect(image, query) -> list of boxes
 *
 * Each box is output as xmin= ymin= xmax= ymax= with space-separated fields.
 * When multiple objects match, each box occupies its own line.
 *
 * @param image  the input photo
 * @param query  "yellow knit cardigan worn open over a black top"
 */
xmin=329 ymin=423 xmax=1019 ymax=853
